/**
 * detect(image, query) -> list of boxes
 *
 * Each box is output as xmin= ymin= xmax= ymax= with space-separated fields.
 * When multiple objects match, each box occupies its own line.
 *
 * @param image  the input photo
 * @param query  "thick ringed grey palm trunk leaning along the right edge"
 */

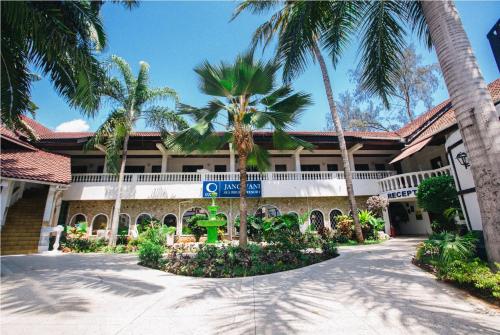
xmin=421 ymin=1 xmax=500 ymax=264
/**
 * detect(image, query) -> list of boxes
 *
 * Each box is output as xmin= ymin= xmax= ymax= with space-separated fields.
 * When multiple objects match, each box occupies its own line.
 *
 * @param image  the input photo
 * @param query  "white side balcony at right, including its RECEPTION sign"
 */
xmin=378 ymin=165 xmax=450 ymax=200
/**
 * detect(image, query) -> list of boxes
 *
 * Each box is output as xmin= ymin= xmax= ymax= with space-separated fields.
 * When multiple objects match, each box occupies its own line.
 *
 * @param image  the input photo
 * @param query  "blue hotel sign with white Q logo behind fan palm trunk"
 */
xmin=203 ymin=180 xmax=262 ymax=198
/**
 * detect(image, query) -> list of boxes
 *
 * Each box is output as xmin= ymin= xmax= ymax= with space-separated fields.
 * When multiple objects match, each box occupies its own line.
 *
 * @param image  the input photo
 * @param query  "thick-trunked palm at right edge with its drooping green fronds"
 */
xmin=352 ymin=1 xmax=500 ymax=264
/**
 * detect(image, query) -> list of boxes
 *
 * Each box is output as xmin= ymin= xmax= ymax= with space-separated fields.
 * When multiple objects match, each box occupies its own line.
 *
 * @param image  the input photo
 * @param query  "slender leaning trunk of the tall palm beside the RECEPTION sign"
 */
xmin=313 ymin=44 xmax=364 ymax=243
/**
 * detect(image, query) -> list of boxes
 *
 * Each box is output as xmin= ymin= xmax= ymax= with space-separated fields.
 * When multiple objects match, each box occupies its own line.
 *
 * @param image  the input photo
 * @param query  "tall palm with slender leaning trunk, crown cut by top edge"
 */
xmin=233 ymin=0 xmax=364 ymax=243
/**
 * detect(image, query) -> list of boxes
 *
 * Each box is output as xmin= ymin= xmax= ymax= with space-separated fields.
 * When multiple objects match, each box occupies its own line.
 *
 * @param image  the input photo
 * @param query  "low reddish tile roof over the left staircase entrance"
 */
xmin=0 ymin=150 xmax=71 ymax=184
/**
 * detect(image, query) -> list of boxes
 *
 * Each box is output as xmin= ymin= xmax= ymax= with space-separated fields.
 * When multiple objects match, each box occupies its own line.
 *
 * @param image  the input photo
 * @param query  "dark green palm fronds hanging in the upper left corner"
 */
xmin=1 ymin=1 xmax=137 ymax=133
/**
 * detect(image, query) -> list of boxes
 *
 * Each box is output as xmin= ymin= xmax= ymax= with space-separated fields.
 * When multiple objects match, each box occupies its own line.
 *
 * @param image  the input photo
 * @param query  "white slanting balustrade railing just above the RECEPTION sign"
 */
xmin=378 ymin=165 xmax=450 ymax=193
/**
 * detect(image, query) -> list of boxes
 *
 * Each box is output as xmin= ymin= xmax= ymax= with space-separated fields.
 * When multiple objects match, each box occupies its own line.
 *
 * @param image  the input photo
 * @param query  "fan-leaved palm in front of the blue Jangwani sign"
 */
xmin=166 ymin=53 xmax=311 ymax=247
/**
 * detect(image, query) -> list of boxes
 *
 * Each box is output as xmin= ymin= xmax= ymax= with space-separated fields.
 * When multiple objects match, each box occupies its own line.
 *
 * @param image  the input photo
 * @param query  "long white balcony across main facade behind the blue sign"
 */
xmin=63 ymin=171 xmax=394 ymax=200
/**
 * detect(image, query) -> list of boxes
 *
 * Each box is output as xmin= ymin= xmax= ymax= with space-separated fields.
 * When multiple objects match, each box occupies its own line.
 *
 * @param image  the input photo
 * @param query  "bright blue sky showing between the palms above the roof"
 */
xmin=32 ymin=1 xmax=500 ymax=130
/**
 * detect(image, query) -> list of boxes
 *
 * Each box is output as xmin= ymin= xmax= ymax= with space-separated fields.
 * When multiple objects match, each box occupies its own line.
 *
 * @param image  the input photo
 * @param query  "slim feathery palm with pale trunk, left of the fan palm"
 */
xmin=86 ymin=56 xmax=187 ymax=246
